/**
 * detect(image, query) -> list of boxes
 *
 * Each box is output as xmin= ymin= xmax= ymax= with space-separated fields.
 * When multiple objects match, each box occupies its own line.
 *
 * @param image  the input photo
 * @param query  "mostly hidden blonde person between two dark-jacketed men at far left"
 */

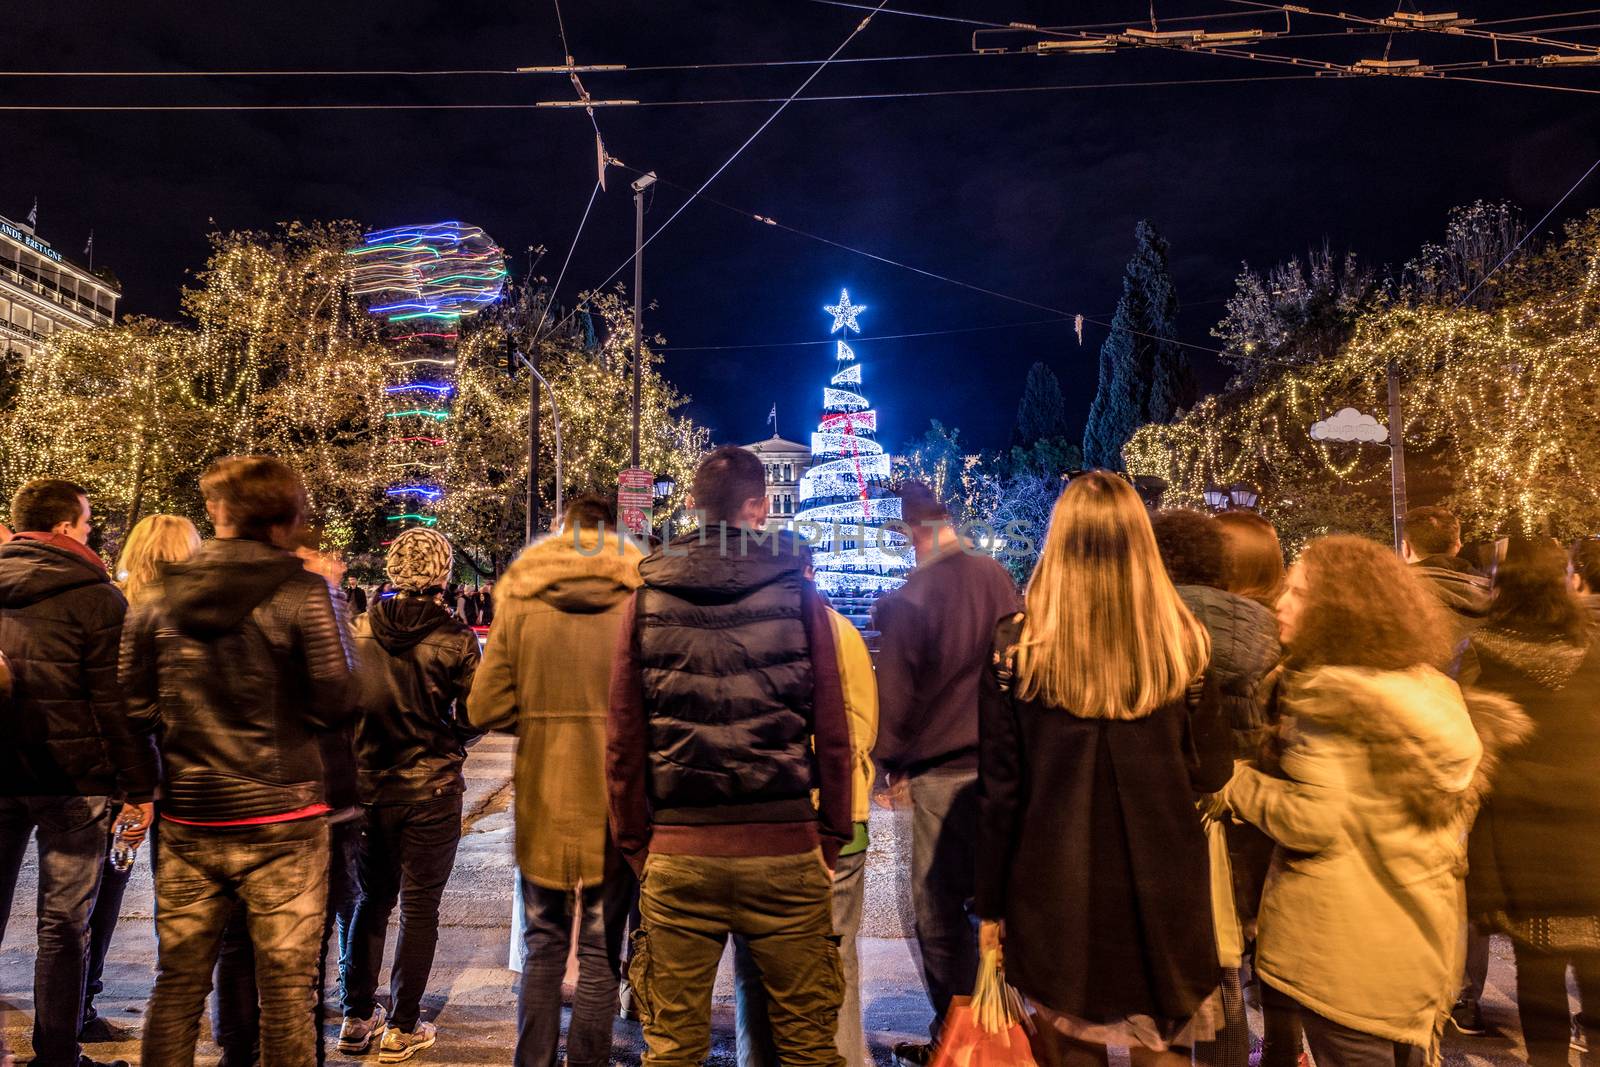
xmin=80 ymin=515 xmax=200 ymax=1041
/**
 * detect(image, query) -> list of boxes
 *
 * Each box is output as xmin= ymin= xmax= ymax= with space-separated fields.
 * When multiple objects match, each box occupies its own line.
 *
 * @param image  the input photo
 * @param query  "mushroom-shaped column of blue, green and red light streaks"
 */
xmin=347 ymin=222 xmax=506 ymax=541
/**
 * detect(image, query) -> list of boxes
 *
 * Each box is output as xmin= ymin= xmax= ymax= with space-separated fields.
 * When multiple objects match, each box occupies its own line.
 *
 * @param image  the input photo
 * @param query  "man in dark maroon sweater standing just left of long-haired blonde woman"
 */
xmin=872 ymin=482 xmax=1018 ymax=1065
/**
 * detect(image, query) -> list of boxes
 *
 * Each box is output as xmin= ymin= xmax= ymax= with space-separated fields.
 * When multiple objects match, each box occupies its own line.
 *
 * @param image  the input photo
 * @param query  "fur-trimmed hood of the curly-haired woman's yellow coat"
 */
xmin=1283 ymin=667 xmax=1533 ymax=827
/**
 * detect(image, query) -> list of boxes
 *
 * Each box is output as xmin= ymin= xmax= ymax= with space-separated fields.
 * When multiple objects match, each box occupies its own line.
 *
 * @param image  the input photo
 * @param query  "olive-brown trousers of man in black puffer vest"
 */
xmin=629 ymin=851 xmax=845 ymax=1067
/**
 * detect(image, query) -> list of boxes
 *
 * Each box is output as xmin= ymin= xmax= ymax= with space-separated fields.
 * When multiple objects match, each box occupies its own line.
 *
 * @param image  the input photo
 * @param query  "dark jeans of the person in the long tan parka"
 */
xmin=517 ymin=864 xmax=638 ymax=1067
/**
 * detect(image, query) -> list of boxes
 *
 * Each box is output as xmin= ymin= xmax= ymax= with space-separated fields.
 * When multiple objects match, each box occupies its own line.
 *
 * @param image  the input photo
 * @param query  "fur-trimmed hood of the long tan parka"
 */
xmin=494 ymin=530 xmax=645 ymax=613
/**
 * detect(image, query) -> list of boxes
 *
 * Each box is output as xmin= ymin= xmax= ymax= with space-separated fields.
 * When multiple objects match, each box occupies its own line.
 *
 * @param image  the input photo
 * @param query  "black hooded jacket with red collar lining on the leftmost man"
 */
xmin=0 ymin=537 xmax=157 ymax=801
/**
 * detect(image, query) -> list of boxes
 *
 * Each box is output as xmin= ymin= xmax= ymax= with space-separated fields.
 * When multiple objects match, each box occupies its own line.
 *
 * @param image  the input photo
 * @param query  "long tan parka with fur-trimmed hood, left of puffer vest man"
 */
xmin=467 ymin=531 xmax=643 ymax=889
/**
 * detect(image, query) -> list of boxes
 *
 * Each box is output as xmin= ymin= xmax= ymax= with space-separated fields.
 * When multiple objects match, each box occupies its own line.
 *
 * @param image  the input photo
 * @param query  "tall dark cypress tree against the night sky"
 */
xmin=1083 ymin=219 xmax=1195 ymax=470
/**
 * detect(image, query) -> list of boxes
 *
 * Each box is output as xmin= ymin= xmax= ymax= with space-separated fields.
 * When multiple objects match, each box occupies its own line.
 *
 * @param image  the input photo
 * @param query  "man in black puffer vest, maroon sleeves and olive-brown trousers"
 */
xmin=606 ymin=446 xmax=854 ymax=1067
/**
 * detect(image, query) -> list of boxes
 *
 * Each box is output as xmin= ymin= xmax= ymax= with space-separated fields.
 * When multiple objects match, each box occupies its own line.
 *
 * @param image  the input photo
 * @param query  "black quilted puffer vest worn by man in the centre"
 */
xmin=635 ymin=531 xmax=818 ymax=824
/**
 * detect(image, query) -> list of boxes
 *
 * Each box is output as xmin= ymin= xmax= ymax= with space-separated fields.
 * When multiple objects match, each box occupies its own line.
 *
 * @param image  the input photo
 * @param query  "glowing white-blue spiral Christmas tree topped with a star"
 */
xmin=795 ymin=290 xmax=910 ymax=604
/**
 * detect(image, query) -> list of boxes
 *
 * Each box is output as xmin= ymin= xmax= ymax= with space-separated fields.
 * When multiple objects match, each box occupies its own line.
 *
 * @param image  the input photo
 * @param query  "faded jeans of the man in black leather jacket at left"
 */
xmin=141 ymin=819 xmax=328 ymax=1067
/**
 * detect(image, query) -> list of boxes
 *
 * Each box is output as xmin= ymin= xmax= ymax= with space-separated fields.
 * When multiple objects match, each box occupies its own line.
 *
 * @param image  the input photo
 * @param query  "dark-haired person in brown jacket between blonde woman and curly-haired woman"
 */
xmin=1150 ymin=510 xmax=1283 ymax=1067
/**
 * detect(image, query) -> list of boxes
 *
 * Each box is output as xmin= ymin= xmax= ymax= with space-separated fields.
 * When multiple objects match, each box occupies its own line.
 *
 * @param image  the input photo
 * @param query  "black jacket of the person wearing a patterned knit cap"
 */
xmin=355 ymin=595 xmax=478 ymax=805
